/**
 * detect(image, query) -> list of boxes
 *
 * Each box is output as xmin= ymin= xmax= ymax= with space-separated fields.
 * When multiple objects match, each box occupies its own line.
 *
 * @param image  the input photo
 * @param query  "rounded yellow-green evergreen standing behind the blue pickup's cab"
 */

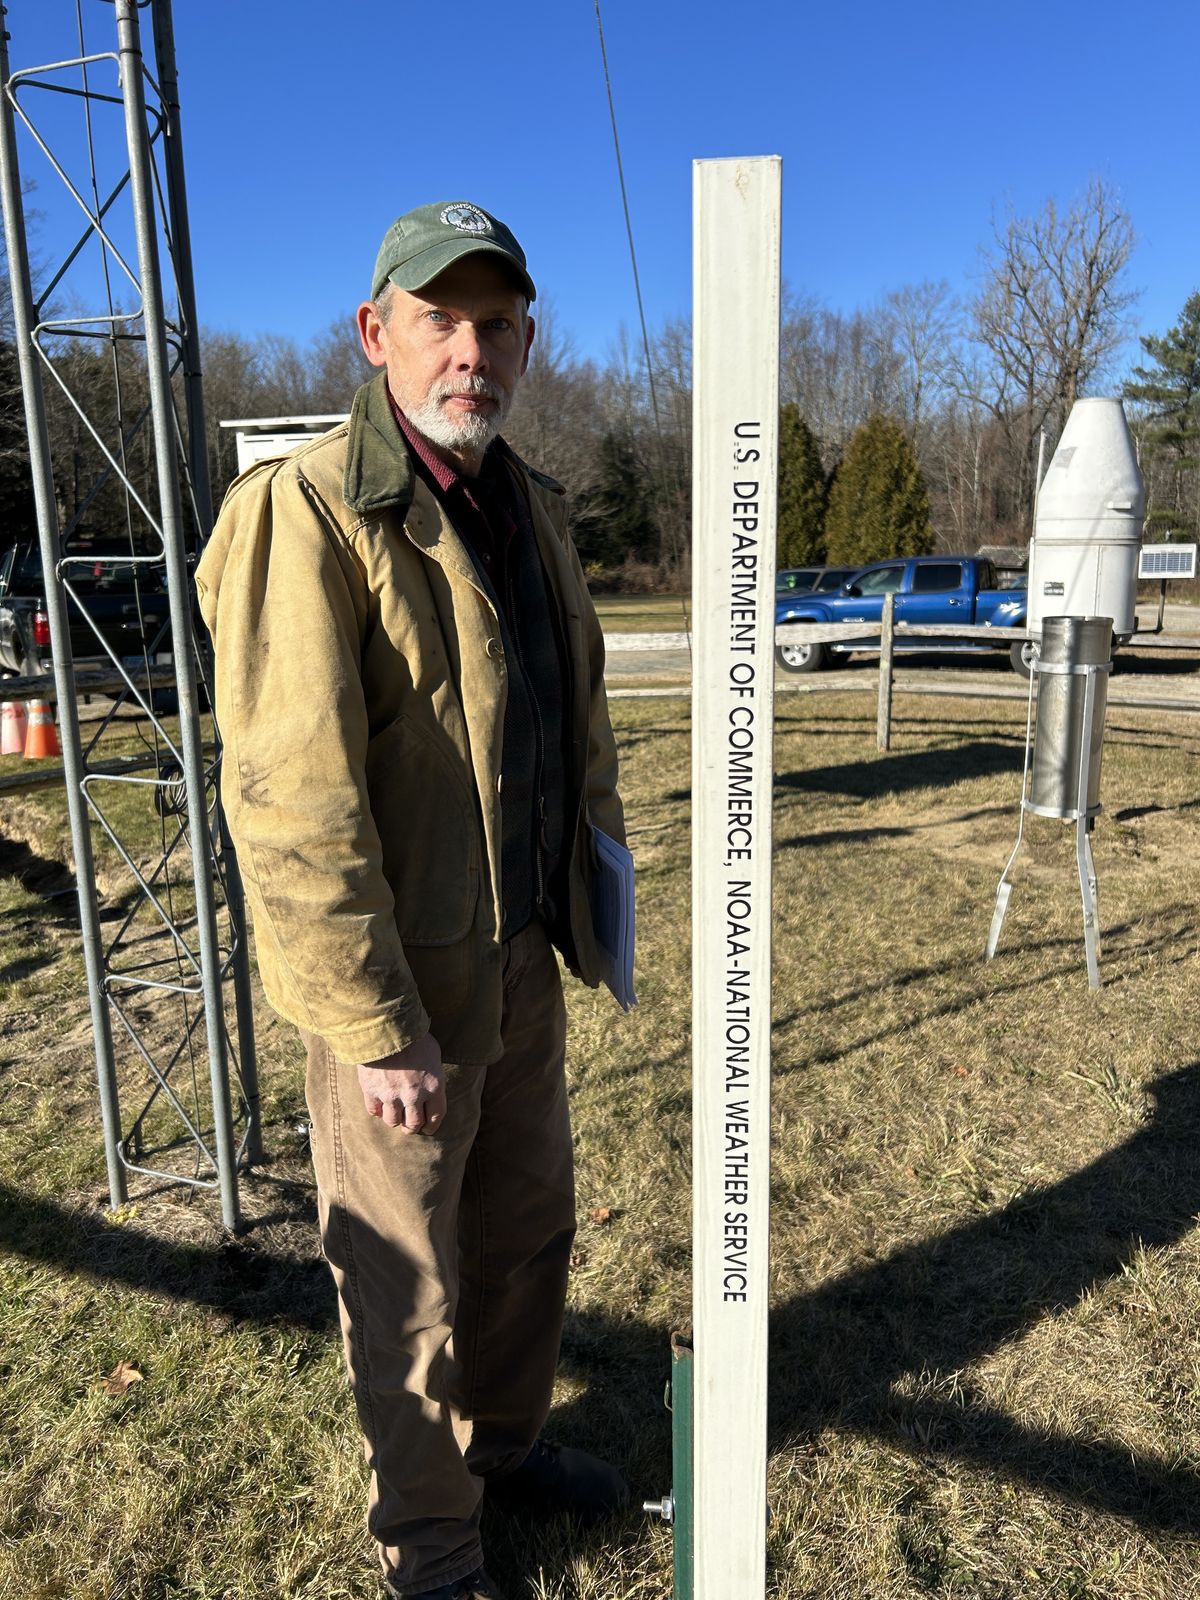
xmin=826 ymin=416 xmax=933 ymax=566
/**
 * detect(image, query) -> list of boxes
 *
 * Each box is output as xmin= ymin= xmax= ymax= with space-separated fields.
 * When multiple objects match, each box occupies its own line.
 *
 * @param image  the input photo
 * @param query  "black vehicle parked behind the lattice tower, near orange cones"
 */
xmin=0 ymin=538 xmax=170 ymax=677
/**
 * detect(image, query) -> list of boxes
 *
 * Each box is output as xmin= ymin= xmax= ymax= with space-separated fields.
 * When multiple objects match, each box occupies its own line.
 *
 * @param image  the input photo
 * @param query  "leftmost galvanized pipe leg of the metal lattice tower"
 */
xmin=0 ymin=8 xmax=128 ymax=1208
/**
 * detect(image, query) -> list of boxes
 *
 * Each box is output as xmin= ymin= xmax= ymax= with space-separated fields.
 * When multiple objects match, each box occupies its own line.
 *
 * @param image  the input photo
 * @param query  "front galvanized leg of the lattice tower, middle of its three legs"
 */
xmin=115 ymin=0 xmax=240 ymax=1229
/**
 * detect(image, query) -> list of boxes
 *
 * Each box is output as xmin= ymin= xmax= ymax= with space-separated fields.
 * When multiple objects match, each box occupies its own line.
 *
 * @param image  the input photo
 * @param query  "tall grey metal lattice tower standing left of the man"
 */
xmin=0 ymin=0 xmax=261 ymax=1227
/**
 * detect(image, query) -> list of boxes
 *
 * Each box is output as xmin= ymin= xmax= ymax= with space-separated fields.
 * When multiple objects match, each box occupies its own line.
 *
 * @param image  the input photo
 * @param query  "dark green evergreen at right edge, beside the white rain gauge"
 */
xmin=1125 ymin=293 xmax=1200 ymax=539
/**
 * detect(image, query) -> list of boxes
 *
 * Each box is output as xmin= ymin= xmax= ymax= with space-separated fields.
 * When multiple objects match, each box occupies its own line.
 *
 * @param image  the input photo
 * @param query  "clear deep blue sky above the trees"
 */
xmin=6 ymin=0 xmax=1200 ymax=368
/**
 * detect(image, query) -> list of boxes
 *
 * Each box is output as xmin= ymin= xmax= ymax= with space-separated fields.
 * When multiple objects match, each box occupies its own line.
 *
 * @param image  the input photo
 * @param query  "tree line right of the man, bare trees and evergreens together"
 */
xmin=509 ymin=181 xmax=1200 ymax=582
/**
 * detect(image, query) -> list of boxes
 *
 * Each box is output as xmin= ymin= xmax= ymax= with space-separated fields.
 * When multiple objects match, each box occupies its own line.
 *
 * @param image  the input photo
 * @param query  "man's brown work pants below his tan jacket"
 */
xmin=306 ymin=923 xmax=574 ymax=1594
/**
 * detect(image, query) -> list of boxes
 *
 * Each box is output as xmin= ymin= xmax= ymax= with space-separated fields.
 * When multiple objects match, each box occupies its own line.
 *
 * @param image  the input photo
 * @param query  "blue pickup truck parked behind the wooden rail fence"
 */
xmin=774 ymin=555 xmax=1029 ymax=677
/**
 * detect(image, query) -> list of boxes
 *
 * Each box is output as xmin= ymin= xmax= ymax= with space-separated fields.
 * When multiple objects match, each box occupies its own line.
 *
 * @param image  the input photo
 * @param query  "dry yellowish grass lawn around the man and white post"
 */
xmin=0 ymin=694 xmax=1200 ymax=1600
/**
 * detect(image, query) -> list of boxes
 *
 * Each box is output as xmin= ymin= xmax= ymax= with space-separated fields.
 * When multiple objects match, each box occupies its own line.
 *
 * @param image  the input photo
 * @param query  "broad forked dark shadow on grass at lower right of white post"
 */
xmin=771 ymin=1062 xmax=1200 ymax=1531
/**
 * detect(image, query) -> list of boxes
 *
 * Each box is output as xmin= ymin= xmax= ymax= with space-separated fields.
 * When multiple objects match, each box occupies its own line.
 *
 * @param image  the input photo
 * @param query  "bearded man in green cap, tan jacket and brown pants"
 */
xmin=197 ymin=203 xmax=627 ymax=1600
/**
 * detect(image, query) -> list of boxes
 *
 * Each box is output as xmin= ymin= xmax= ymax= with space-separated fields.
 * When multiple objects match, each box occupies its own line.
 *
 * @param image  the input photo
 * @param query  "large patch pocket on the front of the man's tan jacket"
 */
xmin=366 ymin=715 xmax=480 ymax=946
